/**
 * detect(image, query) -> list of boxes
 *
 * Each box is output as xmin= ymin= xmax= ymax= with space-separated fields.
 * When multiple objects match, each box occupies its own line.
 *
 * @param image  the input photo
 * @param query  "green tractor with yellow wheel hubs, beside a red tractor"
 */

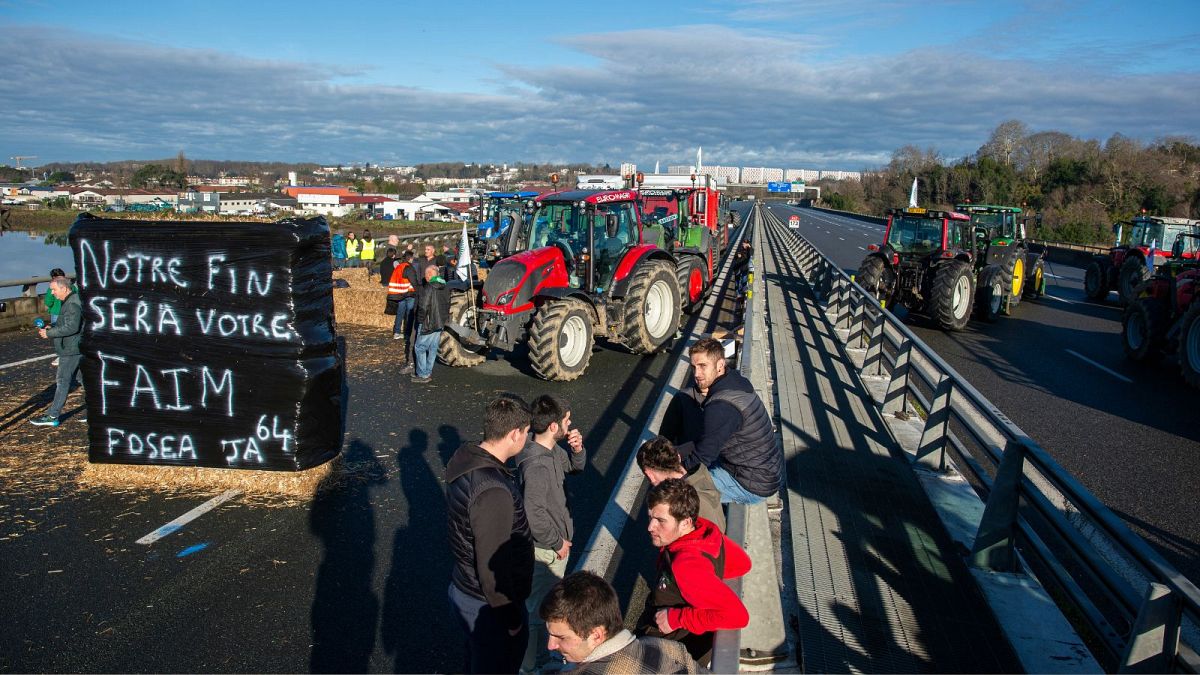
xmin=954 ymin=204 xmax=1046 ymax=321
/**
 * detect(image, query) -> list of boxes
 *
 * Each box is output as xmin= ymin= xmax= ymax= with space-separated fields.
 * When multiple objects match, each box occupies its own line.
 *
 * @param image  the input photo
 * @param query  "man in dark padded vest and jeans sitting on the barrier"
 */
xmin=678 ymin=338 xmax=784 ymax=504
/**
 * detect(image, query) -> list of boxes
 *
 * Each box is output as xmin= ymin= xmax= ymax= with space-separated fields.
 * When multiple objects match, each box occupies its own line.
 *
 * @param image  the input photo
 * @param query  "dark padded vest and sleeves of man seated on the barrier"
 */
xmin=679 ymin=370 xmax=784 ymax=497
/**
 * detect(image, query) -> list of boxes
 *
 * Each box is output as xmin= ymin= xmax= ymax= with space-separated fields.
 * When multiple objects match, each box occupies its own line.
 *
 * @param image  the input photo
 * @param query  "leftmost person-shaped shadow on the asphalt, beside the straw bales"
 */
xmin=308 ymin=440 xmax=388 ymax=673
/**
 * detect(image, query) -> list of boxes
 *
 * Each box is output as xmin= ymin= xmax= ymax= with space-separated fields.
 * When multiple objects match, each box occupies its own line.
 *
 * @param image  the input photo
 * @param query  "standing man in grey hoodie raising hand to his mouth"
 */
xmin=517 ymin=394 xmax=587 ymax=673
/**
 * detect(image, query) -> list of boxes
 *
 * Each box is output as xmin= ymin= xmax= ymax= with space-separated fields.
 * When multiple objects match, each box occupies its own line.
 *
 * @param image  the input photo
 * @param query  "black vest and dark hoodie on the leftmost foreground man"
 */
xmin=445 ymin=443 xmax=533 ymax=628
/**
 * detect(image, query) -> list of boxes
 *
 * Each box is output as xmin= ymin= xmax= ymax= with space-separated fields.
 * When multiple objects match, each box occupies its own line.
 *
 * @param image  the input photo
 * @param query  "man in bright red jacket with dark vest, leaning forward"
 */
xmin=638 ymin=478 xmax=750 ymax=664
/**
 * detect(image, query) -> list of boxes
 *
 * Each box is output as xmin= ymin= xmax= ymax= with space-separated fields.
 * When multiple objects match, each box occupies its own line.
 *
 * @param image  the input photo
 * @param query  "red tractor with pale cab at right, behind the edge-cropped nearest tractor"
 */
xmin=1084 ymin=216 xmax=1200 ymax=305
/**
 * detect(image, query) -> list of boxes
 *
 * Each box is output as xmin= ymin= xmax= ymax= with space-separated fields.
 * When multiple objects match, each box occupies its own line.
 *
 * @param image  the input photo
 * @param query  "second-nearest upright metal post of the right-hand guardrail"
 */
xmin=971 ymin=441 xmax=1025 ymax=572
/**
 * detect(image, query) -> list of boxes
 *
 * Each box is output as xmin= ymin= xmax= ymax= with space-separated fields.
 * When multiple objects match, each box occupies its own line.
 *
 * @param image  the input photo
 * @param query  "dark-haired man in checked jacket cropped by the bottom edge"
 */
xmin=539 ymin=572 xmax=707 ymax=675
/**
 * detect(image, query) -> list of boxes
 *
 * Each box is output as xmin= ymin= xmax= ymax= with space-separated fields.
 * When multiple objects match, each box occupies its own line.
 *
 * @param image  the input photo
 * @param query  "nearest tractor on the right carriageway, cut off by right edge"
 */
xmin=1121 ymin=234 xmax=1200 ymax=388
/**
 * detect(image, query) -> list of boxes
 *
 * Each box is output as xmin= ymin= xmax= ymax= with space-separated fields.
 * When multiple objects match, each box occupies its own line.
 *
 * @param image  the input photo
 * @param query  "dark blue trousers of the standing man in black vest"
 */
xmin=446 ymin=583 xmax=529 ymax=673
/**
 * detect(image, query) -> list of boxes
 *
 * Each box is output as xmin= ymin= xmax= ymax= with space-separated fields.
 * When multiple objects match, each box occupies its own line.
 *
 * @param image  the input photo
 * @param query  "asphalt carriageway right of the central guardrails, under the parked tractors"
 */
xmin=772 ymin=205 xmax=1200 ymax=581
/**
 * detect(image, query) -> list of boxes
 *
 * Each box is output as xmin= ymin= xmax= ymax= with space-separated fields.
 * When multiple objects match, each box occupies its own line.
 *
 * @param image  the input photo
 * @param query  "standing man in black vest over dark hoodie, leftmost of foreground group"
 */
xmin=445 ymin=395 xmax=533 ymax=673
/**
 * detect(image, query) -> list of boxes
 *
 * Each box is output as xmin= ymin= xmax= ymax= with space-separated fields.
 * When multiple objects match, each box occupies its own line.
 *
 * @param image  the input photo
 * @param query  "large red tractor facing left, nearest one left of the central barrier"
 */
xmin=438 ymin=190 xmax=680 ymax=381
